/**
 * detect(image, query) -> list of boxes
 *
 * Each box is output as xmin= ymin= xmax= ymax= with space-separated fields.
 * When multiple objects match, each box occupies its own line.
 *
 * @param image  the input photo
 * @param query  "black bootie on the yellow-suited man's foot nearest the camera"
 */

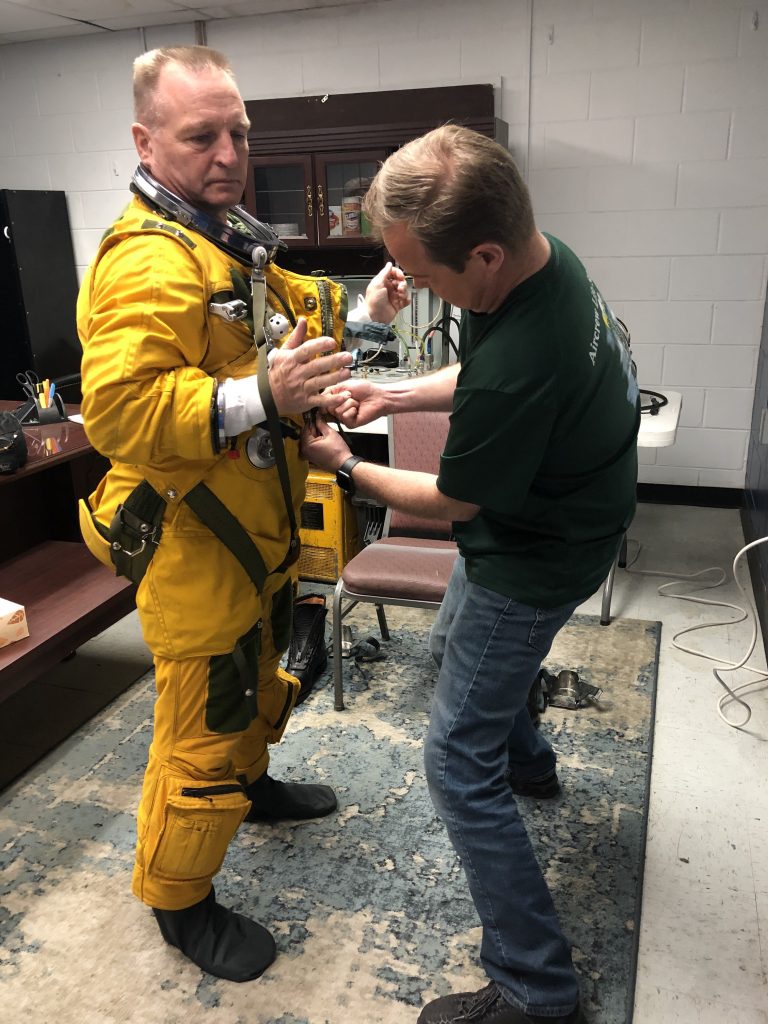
xmin=153 ymin=889 xmax=276 ymax=981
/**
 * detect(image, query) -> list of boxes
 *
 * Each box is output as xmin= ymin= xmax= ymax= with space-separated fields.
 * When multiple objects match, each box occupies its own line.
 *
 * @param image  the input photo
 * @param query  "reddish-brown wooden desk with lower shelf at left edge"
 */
xmin=0 ymin=401 xmax=135 ymax=786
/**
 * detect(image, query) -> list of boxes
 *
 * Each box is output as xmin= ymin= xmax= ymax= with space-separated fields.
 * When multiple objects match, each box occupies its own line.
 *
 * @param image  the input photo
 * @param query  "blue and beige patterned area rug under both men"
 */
xmin=0 ymin=609 xmax=660 ymax=1024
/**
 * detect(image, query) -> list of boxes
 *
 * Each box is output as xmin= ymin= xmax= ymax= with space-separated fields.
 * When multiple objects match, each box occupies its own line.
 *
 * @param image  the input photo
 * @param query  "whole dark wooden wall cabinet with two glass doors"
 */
xmin=245 ymin=85 xmax=508 ymax=275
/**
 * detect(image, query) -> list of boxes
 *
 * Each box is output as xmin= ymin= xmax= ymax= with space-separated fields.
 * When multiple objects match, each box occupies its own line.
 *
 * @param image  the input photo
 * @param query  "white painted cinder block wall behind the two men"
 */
xmin=0 ymin=0 xmax=768 ymax=487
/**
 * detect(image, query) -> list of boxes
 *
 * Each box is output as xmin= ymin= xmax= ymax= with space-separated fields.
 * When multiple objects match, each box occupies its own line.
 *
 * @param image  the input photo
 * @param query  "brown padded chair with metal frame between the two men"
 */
xmin=333 ymin=413 xmax=457 ymax=711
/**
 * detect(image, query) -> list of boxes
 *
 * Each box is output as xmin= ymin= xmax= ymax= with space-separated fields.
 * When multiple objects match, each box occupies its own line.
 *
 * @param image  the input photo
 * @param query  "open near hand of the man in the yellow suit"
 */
xmin=269 ymin=316 xmax=352 ymax=416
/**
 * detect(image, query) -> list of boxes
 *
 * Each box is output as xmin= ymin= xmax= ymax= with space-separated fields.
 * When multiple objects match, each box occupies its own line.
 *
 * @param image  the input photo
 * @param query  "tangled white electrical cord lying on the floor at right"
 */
xmin=627 ymin=537 xmax=768 ymax=729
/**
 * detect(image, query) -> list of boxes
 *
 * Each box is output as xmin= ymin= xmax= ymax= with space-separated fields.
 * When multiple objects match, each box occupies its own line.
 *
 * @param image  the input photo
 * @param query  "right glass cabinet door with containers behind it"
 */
xmin=314 ymin=151 xmax=386 ymax=246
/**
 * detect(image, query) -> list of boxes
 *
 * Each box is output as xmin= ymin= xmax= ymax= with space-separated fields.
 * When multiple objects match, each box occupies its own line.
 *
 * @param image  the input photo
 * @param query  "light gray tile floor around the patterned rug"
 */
xmin=27 ymin=505 xmax=768 ymax=1024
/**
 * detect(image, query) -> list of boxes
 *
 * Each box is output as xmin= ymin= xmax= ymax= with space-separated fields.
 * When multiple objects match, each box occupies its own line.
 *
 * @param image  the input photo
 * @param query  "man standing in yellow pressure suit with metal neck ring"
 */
xmin=78 ymin=46 xmax=408 ymax=981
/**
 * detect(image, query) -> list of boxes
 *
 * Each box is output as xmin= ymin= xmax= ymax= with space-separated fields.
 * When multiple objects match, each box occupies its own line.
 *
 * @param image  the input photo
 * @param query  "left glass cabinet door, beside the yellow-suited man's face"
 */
xmin=246 ymin=156 xmax=317 ymax=246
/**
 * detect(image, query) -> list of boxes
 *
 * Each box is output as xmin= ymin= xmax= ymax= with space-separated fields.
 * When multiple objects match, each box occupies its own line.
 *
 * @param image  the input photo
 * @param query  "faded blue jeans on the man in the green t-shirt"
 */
xmin=424 ymin=557 xmax=579 ymax=1017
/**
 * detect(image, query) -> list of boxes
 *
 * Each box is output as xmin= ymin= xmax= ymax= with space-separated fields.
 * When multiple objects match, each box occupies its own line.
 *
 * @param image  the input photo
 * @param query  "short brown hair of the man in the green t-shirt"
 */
xmin=362 ymin=125 xmax=536 ymax=273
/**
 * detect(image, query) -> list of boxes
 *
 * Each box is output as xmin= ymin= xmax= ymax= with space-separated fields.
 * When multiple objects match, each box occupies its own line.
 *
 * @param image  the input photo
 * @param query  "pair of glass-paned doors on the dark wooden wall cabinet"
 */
xmin=246 ymin=150 xmax=387 ymax=249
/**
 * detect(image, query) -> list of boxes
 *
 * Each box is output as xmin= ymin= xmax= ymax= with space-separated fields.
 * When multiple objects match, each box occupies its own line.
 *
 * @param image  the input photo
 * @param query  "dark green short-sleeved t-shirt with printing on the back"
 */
xmin=437 ymin=236 xmax=640 ymax=607
